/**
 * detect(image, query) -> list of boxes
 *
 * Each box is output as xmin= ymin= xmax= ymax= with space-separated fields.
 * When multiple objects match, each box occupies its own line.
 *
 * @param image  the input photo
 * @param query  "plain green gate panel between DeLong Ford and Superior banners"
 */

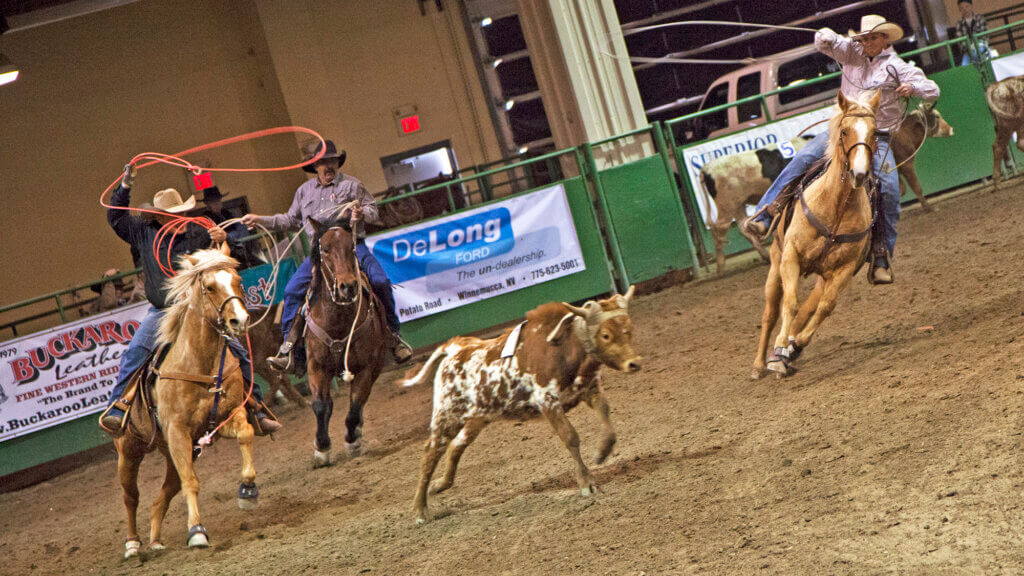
xmin=598 ymin=156 xmax=693 ymax=282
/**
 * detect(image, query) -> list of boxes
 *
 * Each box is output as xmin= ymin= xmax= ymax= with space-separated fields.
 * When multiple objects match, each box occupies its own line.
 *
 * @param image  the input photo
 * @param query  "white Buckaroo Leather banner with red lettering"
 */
xmin=0 ymin=302 xmax=150 ymax=442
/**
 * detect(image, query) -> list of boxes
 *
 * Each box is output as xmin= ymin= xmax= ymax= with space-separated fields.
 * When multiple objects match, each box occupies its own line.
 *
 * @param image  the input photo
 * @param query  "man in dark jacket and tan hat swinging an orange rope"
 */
xmin=99 ymin=164 xmax=281 ymax=438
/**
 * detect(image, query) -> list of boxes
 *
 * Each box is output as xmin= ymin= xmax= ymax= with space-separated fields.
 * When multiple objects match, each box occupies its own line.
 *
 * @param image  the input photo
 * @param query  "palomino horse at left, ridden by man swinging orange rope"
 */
xmin=114 ymin=243 xmax=257 ymax=558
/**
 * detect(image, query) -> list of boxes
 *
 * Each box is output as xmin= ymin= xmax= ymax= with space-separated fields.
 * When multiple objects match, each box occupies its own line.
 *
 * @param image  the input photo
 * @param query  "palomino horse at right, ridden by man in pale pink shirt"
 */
xmin=752 ymin=92 xmax=879 ymax=378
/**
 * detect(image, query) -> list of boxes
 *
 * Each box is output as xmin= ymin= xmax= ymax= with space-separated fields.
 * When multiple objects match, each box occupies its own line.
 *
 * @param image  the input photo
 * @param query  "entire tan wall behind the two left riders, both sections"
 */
xmin=0 ymin=0 xmax=500 ymax=323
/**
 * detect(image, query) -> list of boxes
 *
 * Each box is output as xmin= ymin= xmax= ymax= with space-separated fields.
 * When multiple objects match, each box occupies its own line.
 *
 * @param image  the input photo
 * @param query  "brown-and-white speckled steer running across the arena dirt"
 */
xmin=402 ymin=286 xmax=641 ymax=523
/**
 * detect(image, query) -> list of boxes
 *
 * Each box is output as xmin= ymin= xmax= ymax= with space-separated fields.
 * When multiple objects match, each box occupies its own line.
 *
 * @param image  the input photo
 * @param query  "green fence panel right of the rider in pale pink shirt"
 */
xmin=902 ymin=66 xmax=995 ymax=196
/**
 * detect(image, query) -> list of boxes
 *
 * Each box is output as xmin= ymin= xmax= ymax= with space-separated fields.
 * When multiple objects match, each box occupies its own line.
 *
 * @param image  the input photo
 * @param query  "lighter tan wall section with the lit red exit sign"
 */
xmin=256 ymin=0 xmax=501 ymax=193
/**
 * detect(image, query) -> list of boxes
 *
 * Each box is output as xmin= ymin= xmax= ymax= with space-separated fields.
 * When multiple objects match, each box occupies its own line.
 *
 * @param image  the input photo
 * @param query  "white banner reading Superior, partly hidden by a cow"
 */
xmin=683 ymin=106 xmax=836 ymax=225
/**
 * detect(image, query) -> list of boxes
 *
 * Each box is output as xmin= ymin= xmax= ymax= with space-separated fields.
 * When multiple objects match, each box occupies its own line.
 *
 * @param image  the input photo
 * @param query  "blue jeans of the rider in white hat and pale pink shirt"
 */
xmin=758 ymin=132 xmax=900 ymax=254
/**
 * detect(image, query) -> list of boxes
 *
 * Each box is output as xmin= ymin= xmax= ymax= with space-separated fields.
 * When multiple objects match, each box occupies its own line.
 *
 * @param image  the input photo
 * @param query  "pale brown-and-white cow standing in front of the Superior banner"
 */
xmin=700 ymin=137 xmax=810 ymax=276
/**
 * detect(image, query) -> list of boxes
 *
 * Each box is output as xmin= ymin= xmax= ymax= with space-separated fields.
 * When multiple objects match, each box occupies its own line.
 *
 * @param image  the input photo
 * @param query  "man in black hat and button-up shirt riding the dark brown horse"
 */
xmin=242 ymin=140 xmax=413 ymax=372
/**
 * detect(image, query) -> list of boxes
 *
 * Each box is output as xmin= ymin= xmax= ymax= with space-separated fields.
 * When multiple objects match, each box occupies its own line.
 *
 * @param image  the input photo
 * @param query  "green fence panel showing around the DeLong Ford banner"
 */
xmin=401 ymin=175 xmax=610 ymax=347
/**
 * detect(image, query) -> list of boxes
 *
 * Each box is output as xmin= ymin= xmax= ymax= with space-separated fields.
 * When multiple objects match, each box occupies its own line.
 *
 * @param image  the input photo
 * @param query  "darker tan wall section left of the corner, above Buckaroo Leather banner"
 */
xmin=0 ymin=0 xmax=303 ymax=311
